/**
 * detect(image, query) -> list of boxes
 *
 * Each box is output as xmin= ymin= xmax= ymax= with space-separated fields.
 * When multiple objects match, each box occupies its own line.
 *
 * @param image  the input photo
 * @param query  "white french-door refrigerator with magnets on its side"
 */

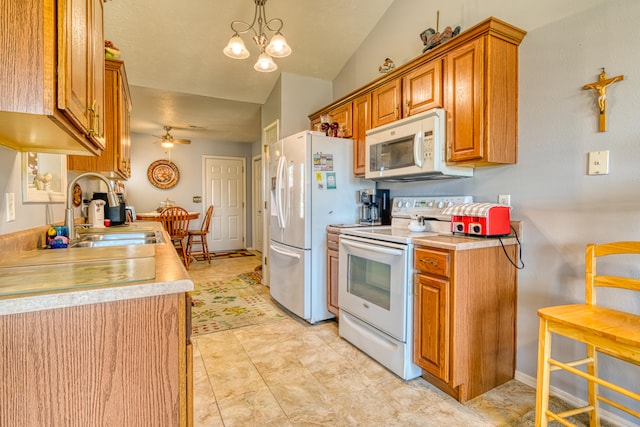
xmin=267 ymin=131 xmax=371 ymax=324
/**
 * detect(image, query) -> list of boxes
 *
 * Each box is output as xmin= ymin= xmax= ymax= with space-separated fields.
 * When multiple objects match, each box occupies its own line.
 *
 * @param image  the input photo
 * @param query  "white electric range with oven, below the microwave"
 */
xmin=338 ymin=196 xmax=473 ymax=380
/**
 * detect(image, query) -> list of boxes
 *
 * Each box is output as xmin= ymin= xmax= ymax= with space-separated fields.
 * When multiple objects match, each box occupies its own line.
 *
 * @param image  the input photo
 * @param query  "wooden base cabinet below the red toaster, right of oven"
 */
xmin=413 ymin=245 xmax=517 ymax=402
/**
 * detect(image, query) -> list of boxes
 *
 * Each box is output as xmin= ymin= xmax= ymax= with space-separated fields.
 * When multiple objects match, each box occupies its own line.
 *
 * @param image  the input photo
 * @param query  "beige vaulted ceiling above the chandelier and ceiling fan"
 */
xmin=104 ymin=0 xmax=393 ymax=142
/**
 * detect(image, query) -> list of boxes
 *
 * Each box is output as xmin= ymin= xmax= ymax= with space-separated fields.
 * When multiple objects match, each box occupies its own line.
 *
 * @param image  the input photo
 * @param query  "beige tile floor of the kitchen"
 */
xmin=190 ymin=252 xmax=535 ymax=427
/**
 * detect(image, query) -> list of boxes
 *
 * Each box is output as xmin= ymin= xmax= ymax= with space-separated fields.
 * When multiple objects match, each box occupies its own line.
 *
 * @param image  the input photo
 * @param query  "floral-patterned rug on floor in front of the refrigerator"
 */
xmin=191 ymin=271 xmax=287 ymax=335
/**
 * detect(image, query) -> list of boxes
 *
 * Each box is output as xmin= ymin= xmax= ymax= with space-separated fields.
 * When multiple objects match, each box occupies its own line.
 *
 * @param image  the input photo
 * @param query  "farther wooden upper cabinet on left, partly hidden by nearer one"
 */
xmin=67 ymin=59 xmax=131 ymax=179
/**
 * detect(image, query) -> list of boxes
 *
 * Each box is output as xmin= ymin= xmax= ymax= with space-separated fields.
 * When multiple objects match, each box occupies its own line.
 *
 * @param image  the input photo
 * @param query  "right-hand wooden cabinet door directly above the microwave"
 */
xmin=402 ymin=59 xmax=443 ymax=117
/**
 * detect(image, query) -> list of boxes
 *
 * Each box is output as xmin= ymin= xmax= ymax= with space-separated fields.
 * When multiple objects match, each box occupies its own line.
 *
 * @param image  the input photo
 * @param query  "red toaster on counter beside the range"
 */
xmin=442 ymin=203 xmax=511 ymax=236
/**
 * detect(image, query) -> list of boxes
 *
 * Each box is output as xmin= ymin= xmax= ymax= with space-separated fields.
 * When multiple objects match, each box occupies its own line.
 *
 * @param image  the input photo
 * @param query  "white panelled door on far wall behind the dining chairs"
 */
xmin=203 ymin=156 xmax=246 ymax=252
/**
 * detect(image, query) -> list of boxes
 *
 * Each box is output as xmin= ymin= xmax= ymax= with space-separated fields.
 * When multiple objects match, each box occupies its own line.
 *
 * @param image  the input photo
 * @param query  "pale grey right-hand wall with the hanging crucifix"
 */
xmin=334 ymin=0 xmax=640 ymax=421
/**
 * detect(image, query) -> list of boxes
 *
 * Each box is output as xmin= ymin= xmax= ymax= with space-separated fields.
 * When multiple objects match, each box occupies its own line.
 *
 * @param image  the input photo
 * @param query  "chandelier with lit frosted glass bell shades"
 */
xmin=223 ymin=0 xmax=291 ymax=72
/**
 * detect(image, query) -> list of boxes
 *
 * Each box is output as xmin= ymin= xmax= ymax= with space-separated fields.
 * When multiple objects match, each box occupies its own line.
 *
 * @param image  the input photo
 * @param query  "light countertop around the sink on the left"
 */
xmin=0 ymin=221 xmax=193 ymax=315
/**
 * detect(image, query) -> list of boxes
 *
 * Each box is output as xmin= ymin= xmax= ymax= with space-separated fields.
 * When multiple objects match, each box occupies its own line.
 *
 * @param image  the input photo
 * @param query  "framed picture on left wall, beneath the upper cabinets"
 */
xmin=22 ymin=152 xmax=67 ymax=203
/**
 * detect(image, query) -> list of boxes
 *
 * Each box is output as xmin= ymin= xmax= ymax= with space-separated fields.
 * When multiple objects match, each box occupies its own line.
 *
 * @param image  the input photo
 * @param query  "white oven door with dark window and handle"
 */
xmin=338 ymin=235 xmax=409 ymax=342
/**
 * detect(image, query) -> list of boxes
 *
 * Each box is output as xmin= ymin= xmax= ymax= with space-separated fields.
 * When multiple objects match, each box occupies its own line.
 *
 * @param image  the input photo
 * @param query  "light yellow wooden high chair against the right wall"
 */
xmin=536 ymin=242 xmax=640 ymax=427
